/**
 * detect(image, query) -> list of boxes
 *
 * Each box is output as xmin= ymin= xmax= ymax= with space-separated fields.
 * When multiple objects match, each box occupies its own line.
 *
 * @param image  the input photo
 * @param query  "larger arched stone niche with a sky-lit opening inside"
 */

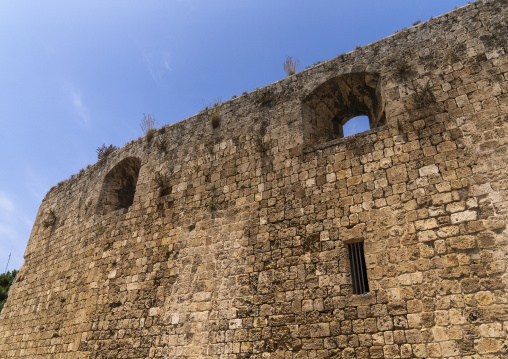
xmin=302 ymin=72 xmax=386 ymax=144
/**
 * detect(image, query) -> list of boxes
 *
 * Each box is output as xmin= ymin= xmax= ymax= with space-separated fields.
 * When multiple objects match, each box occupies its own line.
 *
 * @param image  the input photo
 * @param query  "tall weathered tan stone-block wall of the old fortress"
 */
xmin=0 ymin=0 xmax=508 ymax=359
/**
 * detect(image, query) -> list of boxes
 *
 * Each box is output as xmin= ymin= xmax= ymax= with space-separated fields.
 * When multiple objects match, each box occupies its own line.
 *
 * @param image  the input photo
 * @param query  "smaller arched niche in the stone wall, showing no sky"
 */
xmin=97 ymin=157 xmax=141 ymax=214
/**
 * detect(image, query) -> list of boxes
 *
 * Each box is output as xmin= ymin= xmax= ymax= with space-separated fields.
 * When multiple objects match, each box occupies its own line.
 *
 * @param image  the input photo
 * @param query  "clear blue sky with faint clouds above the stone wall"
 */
xmin=0 ymin=0 xmax=467 ymax=273
